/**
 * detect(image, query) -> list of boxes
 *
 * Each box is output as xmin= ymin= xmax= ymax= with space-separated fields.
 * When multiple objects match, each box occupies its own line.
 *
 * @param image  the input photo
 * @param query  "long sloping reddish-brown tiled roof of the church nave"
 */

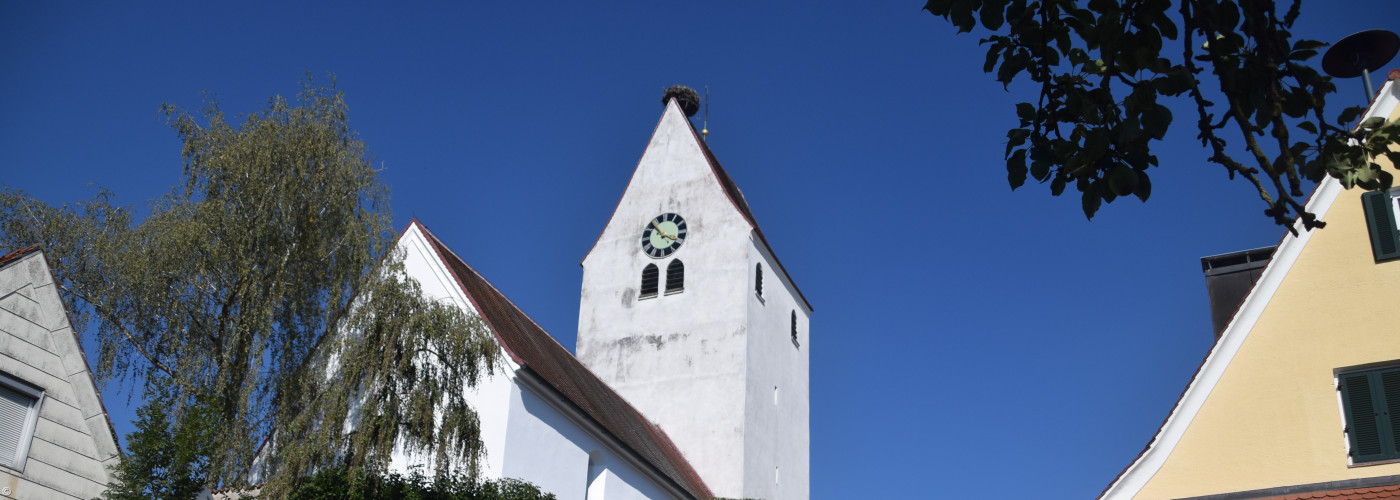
xmin=410 ymin=218 xmax=713 ymax=499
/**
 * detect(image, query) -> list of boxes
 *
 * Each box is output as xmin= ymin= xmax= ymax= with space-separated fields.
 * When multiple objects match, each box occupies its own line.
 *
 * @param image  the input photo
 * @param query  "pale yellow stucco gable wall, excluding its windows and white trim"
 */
xmin=1138 ymin=100 xmax=1400 ymax=499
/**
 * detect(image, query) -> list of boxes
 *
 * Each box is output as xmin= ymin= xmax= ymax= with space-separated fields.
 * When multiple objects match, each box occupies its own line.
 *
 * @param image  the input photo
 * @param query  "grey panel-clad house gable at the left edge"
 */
xmin=0 ymin=246 xmax=118 ymax=500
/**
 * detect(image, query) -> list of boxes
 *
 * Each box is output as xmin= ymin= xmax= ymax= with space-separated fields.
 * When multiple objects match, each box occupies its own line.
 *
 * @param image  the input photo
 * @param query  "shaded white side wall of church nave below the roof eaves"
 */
xmin=503 ymin=378 xmax=675 ymax=500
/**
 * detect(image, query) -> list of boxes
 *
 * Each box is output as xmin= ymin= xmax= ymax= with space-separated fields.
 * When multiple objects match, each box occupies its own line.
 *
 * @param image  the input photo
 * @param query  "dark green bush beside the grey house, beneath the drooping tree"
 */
xmin=105 ymin=381 xmax=220 ymax=500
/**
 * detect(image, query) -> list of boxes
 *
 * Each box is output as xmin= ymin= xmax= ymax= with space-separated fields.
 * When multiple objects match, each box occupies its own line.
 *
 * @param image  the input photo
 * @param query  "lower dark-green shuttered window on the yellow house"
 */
xmin=1337 ymin=367 xmax=1400 ymax=464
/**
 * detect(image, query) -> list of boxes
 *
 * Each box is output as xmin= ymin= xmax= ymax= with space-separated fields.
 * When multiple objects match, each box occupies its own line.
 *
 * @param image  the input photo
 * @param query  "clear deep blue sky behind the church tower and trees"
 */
xmin=0 ymin=0 xmax=1400 ymax=499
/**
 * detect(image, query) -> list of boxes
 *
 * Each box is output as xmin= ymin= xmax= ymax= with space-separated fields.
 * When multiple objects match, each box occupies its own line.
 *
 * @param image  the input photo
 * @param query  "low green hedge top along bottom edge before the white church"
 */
xmin=287 ymin=468 xmax=554 ymax=500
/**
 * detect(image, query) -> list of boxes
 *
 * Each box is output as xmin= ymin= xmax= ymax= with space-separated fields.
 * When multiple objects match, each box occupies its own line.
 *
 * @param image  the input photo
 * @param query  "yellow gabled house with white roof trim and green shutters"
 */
xmin=1100 ymin=74 xmax=1400 ymax=500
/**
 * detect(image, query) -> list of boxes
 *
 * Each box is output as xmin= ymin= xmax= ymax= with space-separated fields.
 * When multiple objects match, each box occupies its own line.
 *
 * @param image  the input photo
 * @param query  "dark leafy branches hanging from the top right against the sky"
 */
xmin=924 ymin=0 xmax=1400 ymax=228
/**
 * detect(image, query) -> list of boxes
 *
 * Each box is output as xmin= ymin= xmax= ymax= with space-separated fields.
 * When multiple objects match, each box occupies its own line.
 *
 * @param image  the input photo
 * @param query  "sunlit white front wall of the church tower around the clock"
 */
xmin=577 ymin=104 xmax=750 ymax=497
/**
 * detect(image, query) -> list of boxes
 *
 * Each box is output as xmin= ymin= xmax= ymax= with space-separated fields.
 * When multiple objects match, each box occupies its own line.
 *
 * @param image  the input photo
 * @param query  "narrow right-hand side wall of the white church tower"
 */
xmin=743 ymin=234 xmax=812 ymax=499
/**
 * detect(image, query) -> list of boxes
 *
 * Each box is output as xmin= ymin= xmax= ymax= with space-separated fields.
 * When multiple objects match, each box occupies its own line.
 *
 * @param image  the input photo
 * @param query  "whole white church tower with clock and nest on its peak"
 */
xmin=575 ymin=87 xmax=812 ymax=500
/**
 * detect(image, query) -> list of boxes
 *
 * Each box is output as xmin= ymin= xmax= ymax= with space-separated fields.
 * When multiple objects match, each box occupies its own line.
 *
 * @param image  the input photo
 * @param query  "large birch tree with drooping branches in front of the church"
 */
xmin=0 ymin=73 xmax=498 ymax=497
